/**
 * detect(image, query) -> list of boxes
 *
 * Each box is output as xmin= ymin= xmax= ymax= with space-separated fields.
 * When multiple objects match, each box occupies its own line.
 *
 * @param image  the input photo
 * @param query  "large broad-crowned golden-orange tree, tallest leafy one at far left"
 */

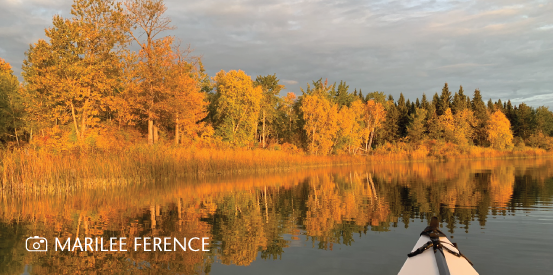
xmin=23 ymin=0 xmax=126 ymax=139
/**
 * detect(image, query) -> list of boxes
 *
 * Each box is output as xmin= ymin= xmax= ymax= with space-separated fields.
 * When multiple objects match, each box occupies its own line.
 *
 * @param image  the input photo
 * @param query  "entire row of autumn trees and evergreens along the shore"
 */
xmin=0 ymin=0 xmax=553 ymax=155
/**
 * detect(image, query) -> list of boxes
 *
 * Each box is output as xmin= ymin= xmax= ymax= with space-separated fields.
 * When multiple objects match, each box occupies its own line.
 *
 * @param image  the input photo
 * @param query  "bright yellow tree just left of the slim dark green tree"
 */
xmin=215 ymin=70 xmax=263 ymax=145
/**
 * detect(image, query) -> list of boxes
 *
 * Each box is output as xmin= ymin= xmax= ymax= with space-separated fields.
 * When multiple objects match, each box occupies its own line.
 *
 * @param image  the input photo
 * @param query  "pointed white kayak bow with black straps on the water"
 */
xmin=398 ymin=218 xmax=478 ymax=275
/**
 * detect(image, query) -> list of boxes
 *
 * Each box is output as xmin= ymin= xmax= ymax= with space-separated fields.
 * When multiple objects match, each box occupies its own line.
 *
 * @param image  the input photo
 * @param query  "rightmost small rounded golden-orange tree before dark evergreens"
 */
xmin=486 ymin=110 xmax=513 ymax=149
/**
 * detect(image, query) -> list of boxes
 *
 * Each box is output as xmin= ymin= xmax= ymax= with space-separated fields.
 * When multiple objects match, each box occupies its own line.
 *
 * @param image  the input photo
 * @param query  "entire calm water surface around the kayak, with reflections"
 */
xmin=0 ymin=159 xmax=553 ymax=274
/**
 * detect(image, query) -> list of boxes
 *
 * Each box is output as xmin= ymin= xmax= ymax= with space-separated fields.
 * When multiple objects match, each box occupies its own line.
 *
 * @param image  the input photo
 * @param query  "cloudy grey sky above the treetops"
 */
xmin=0 ymin=0 xmax=553 ymax=109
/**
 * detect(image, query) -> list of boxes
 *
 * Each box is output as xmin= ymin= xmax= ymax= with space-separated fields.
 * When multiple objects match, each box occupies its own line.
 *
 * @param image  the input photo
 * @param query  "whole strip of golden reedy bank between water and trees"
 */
xmin=0 ymin=141 xmax=553 ymax=195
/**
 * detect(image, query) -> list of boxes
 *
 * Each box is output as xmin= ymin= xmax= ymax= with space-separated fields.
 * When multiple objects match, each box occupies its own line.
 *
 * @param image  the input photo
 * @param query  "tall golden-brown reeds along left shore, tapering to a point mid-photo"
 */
xmin=0 ymin=145 xmax=364 ymax=195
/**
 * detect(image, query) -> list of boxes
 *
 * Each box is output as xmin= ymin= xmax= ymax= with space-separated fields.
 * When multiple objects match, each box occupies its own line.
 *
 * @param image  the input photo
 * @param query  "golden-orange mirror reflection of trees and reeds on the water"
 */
xmin=0 ymin=159 xmax=553 ymax=274
